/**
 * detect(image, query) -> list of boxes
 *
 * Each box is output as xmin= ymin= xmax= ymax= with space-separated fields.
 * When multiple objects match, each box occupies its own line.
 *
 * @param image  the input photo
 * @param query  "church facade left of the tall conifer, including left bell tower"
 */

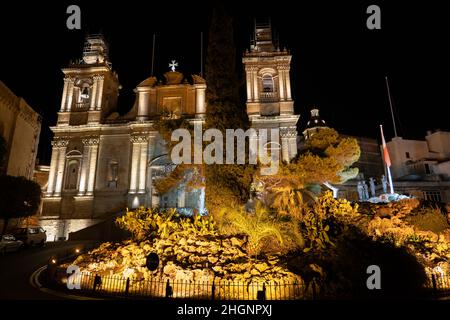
xmin=40 ymin=35 xmax=206 ymax=239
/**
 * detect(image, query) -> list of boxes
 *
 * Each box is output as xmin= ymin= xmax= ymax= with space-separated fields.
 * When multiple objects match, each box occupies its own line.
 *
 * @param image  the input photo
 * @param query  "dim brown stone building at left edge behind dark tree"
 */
xmin=0 ymin=81 xmax=42 ymax=179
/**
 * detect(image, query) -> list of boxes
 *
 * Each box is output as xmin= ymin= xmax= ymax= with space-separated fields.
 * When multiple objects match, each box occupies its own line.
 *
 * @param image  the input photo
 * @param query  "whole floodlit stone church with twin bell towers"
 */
xmin=40 ymin=23 xmax=299 ymax=240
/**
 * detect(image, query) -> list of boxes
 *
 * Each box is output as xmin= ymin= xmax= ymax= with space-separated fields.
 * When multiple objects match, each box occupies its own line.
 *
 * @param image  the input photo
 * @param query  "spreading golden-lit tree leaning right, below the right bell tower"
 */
xmin=258 ymin=128 xmax=361 ymax=220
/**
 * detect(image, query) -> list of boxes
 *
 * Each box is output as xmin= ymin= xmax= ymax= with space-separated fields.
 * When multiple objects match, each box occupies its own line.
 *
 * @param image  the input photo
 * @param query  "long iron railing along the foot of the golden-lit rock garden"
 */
xmin=56 ymin=272 xmax=316 ymax=300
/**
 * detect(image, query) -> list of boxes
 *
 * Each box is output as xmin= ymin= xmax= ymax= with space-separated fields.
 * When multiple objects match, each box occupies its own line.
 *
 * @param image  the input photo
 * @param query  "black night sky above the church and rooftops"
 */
xmin=0 ymin=0 xmax=450 ymax=164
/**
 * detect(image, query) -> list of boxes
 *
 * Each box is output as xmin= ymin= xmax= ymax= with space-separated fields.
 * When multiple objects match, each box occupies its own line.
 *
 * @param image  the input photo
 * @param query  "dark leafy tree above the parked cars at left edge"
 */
xmin=0 ymin=175 xmax=41 ymax=235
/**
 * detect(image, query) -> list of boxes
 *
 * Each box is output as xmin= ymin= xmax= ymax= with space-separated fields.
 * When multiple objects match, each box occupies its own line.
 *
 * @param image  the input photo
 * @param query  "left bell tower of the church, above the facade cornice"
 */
xmin=57 ymin=35 xmax=120 ymax=126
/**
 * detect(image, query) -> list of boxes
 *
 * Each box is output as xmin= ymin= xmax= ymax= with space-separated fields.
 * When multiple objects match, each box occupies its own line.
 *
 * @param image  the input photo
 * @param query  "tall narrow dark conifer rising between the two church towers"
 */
xmin=204 ymin=4 xmax=254 ymax=214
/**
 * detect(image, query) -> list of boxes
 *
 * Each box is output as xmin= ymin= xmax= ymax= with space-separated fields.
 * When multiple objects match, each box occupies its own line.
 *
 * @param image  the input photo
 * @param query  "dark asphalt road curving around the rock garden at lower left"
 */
xmin=0 ymin=241 xmax=95 ymax=300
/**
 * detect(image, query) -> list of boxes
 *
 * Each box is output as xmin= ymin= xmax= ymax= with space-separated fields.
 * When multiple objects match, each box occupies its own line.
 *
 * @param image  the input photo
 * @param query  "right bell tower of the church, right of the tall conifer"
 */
xmin=242 ymin=20 xmax=299 ymax=162
